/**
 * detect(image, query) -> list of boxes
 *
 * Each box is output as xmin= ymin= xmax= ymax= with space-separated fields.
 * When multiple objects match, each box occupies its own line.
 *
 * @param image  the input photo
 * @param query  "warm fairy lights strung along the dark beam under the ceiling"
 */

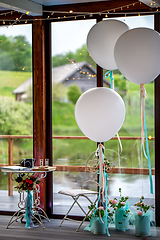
xmin=0 ymin=1 xmax=160 ymax=27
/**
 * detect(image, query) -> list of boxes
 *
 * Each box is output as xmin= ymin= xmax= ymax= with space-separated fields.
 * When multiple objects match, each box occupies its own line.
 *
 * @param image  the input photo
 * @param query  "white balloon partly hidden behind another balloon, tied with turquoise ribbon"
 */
xmin=87 ymin=19 xmax=129 ymax=70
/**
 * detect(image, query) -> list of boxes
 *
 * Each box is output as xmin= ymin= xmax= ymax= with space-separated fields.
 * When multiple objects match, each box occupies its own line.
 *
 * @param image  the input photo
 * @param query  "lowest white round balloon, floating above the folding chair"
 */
xmin=75 ymin=87 xmax=125 ymax=142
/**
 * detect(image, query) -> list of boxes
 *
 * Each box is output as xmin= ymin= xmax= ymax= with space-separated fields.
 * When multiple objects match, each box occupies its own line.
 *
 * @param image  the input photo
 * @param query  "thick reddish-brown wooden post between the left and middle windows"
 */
xmin=32 ymin=20 xmax=46 ymax=211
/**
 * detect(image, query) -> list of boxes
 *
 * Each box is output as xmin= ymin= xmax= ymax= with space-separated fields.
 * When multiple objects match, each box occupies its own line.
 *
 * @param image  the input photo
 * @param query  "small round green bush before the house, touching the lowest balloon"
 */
xmin=67 ymin=84 xmax=82 ymax=104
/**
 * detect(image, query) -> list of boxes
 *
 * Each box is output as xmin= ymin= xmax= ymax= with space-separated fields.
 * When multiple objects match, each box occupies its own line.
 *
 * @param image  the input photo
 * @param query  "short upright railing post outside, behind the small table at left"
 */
xmin=8 ymin=137 xmax=13 ymax=196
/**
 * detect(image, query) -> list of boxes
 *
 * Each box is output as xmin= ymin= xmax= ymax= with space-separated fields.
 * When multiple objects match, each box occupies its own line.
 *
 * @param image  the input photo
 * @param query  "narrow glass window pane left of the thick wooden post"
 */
xmin=0 ymin=24 xmax=33 ymax=211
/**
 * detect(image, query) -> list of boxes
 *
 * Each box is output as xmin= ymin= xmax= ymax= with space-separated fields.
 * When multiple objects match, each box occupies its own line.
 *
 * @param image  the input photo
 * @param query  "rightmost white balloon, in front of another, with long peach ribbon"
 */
xmin=114 ymin=28 xmax=160 ymax=84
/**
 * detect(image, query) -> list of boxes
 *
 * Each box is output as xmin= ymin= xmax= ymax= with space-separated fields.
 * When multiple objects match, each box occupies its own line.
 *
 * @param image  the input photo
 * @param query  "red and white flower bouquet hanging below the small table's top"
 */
xmin=15 ymin=173 xmax=40 ymax=192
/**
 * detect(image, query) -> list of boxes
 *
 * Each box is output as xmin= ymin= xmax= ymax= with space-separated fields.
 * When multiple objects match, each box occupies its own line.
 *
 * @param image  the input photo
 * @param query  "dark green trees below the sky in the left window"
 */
xmin=0 ymin=35 xmax=32 ymax=72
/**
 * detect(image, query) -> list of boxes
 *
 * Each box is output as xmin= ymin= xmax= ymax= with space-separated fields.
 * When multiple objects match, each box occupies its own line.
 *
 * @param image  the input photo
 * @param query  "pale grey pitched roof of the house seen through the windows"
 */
xmin=13 ymin=62 xmax=110 ymax=94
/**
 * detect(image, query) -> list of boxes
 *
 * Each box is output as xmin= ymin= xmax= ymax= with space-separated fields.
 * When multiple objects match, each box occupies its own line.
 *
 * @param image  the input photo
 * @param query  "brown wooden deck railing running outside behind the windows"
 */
xmin=0 ymin=135 xmax=155 ymax=196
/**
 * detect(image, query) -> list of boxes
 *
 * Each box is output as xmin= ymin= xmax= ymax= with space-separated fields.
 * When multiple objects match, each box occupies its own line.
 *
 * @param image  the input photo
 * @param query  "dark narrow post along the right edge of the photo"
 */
xmin=154 ymin=13 xmax=160 ymax=227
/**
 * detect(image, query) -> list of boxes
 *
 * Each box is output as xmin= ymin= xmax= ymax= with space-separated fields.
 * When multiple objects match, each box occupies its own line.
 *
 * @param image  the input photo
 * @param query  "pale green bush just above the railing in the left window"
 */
xmin=0 ymin=96 xmax=32 ymax=135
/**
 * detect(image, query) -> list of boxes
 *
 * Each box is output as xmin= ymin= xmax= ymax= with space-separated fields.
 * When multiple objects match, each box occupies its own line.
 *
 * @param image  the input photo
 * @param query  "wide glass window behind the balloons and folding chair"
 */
xmin=52 ymin=16 xmax=155 ymax=215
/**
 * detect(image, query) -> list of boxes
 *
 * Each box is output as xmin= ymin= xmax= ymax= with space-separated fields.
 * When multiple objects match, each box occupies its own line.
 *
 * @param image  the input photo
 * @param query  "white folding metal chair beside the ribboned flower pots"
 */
xmin=58 ymin=151 xmax=98 ymax=231
